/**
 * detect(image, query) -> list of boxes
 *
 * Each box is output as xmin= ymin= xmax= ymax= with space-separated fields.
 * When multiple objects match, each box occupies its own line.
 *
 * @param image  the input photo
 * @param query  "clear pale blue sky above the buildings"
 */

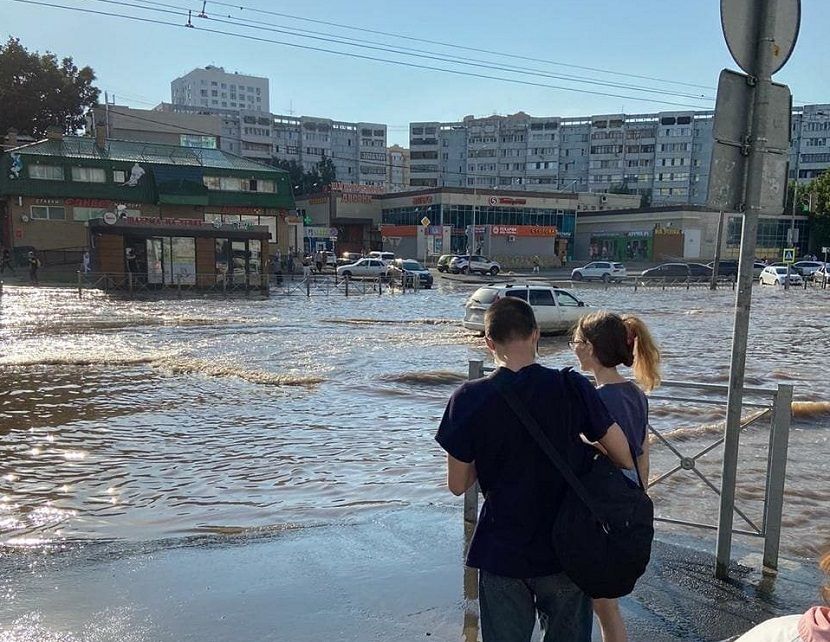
xmin=0 ymin=0 xmax=830 ymax=144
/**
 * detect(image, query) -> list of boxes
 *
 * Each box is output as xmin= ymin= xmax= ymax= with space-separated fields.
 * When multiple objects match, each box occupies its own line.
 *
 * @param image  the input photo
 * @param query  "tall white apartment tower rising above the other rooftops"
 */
xmin=170 ymin=65 xmax=271 ymax=114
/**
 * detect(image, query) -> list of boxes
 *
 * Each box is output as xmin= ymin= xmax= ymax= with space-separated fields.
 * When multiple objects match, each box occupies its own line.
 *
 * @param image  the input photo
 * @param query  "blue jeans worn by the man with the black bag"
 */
xmin=478 ymin=571 xmax=593 ymax=642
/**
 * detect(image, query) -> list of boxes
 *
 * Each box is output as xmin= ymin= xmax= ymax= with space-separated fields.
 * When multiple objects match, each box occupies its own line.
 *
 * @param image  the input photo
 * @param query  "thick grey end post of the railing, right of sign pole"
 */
xmin=764 ymin=383 xmax=793 ymax=571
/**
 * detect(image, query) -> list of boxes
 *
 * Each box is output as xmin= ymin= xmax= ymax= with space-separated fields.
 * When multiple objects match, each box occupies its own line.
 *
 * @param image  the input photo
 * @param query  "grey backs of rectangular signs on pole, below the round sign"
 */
xmin=709 ymin=69 xmax=792 ymax=214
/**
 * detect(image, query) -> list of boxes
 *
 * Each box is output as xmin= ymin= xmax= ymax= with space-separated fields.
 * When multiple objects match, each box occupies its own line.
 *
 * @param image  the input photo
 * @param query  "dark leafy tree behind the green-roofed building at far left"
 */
xmin=0 ymin=38 xmax=101 ymax=138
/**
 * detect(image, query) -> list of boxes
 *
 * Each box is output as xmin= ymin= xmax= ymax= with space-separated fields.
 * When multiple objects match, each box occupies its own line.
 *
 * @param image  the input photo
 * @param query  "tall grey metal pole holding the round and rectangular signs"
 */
xmin=715 ymin=0 xmax=778 ymax=579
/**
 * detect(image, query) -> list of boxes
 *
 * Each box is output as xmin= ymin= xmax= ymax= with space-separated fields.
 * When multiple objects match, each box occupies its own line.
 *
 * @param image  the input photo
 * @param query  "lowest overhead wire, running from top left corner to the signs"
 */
xmin=10 ymin=0 xmax=716 ymax=109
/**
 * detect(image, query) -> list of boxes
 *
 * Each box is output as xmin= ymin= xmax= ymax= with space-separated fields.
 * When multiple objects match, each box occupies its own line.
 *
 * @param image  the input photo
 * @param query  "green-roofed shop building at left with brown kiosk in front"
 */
xmin=0 ymin=130 xmax=295 ymax=285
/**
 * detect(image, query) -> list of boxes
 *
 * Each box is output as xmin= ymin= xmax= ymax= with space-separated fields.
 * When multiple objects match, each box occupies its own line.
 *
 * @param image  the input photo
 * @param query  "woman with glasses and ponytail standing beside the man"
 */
xmin=570 ymin=312 xmax=660 ymax=642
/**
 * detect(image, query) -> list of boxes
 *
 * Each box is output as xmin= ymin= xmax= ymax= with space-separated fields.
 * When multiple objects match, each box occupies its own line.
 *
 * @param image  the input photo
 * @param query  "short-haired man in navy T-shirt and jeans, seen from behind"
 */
xmin=435 ymin=297 xmax=633 ymax=642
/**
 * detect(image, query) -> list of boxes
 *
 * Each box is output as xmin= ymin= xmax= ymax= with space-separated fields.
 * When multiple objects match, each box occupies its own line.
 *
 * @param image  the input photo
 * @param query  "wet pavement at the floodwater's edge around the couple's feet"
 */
xmin=0 ymin=506 xmax=820 ymax=642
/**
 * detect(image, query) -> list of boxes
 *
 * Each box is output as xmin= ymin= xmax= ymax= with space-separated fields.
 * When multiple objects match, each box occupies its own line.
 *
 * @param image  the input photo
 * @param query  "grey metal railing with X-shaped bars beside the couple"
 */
xmin=464 ymin=360 xmax=793 ymax=571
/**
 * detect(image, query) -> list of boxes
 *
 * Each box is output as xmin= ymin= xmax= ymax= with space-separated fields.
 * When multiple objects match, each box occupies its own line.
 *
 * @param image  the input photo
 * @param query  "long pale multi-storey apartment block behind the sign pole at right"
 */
xmin=409 ymin=105 xmax=830 ymax=205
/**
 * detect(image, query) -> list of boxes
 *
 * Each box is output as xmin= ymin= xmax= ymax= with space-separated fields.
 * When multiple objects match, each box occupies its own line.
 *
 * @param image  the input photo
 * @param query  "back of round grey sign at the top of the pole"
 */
xmin=720 ymin=0 xmax=801 ymax=74
